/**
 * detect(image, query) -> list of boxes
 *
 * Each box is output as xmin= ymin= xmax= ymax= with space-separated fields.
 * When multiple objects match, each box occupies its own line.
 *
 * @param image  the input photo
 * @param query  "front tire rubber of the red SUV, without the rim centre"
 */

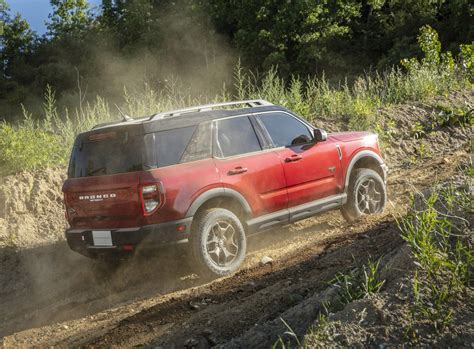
xmin=341 ymin=168 xmax=387 ymax=223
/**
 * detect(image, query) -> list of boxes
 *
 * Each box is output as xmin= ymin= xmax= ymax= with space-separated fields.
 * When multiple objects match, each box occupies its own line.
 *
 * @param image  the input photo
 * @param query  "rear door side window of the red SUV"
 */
xmin=216 ymin=116 xmax=262 ymax=157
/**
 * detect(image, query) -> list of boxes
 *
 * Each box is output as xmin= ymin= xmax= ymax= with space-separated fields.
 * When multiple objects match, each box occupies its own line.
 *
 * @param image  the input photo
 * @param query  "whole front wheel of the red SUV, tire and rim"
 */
xmin=341 ymin=168 xmax=387 ymax=223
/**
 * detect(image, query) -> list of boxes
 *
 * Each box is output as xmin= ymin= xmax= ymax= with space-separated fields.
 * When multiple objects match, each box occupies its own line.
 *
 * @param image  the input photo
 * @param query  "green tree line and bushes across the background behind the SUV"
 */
xmin=0 ymin=0 xmax=474 ymax=112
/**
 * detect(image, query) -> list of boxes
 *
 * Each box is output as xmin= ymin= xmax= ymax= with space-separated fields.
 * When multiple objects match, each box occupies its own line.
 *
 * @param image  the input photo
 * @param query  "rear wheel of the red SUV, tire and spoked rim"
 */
xmin=191 ymin=208 xmax=247 ymax=277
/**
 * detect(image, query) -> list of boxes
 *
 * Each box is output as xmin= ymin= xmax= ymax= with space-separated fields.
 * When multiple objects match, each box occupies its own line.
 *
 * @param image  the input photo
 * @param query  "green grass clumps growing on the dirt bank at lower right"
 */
xmin=290 ymin=175 xmax=474 ymax=348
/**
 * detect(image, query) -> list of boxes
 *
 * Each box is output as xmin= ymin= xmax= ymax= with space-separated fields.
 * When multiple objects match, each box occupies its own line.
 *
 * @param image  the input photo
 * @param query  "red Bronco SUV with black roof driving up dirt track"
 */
xmin=63 ymin=100 xmax=387 ymax=275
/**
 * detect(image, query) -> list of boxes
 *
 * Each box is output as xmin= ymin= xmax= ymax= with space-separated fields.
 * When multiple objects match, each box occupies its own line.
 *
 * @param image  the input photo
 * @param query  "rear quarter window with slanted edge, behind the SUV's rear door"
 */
xmin=155 ymin=126 xmax=196 ymax=167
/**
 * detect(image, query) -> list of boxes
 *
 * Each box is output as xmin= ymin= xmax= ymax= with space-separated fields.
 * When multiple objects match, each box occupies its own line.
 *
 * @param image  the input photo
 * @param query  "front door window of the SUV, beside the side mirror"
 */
xmin=258 ymin=113 xmax=313 ymax=147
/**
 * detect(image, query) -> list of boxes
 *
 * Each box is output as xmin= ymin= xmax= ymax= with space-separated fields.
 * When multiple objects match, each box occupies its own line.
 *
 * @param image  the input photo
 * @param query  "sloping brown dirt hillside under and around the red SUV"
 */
xmin=0 ymin=89 xmax=474 ymax=348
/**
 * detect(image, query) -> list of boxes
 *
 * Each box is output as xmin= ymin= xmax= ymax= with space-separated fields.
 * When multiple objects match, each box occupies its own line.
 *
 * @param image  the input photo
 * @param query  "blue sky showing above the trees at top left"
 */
xmin=7 ymin=0 xmax=101 ymax=35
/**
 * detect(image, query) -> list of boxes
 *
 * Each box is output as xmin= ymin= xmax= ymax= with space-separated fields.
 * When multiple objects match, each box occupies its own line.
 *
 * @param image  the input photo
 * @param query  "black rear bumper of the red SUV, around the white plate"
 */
xmin=66 ymin=217 xmax=192 ymax=257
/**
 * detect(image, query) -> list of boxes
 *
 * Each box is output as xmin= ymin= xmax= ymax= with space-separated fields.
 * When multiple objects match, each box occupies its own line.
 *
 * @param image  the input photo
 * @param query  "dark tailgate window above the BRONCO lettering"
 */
xmin=68 ymin=133 xmax=146 ymax=178
